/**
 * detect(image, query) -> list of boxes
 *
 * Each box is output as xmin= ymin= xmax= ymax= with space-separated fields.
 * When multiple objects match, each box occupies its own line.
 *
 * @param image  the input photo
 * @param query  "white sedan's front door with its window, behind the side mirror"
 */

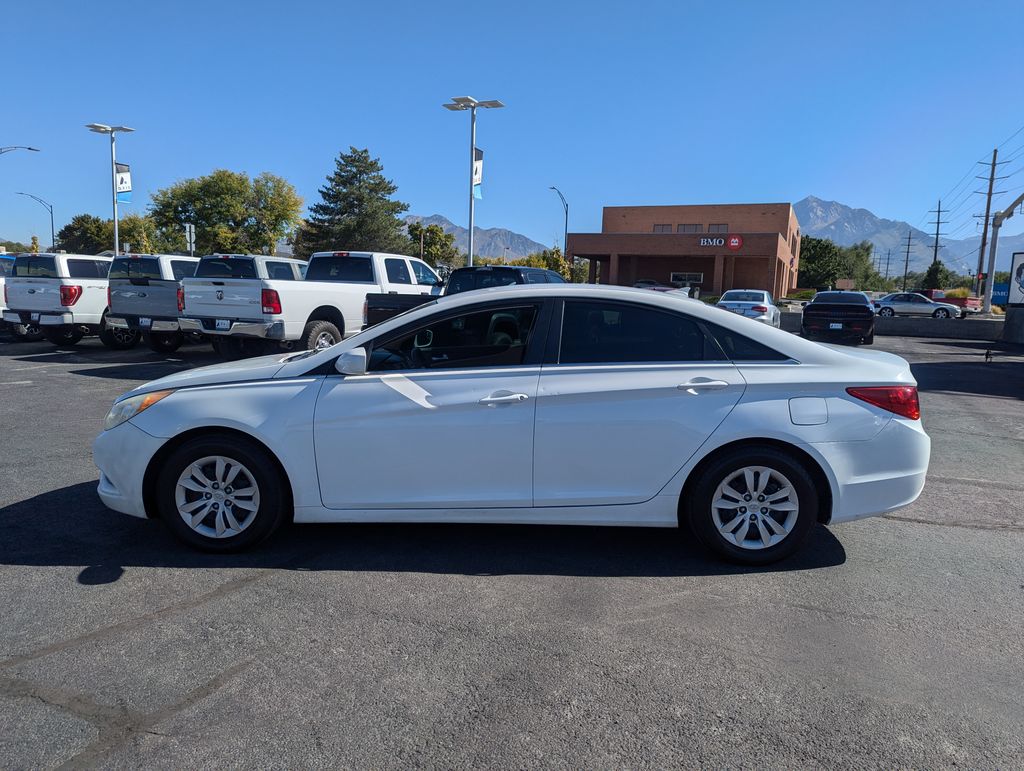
xmin=313 ymin=300 xmax=550 ymax=509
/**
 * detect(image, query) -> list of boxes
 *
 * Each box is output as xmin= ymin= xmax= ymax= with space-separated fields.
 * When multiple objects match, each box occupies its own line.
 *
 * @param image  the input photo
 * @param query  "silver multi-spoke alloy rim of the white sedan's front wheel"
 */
xmin=174 ymin=456 xmax=260 ymax=539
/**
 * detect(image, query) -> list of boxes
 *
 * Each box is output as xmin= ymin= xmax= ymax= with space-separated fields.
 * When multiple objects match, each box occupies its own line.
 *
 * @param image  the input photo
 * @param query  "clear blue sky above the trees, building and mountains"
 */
xmin=0 ymin=0 xmax=1024 ymax=244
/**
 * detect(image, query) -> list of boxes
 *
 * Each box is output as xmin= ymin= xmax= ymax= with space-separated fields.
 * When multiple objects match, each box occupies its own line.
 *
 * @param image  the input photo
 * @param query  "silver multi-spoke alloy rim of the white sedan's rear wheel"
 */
xmin=711 ymin=466 xmax=800 ymax=550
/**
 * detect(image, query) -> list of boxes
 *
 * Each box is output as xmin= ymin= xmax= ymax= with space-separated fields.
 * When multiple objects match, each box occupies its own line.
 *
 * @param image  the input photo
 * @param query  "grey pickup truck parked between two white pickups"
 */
xmin=106 ymin=254 xmax=199 ymax=353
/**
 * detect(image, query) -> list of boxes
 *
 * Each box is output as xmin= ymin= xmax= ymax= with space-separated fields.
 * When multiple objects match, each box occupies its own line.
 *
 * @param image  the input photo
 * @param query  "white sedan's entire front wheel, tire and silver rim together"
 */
xmin=157 ymin=436 xmax=290 ymax=552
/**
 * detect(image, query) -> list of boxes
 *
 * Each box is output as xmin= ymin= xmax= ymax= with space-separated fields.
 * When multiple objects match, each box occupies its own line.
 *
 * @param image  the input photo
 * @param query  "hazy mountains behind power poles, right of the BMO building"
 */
xmin=793 ymin=196 xmax=1024 ymax=275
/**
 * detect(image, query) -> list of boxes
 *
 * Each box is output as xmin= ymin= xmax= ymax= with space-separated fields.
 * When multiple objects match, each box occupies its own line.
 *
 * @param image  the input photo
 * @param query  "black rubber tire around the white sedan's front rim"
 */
xmin=157 ymin=435 xmax=292 ymax=553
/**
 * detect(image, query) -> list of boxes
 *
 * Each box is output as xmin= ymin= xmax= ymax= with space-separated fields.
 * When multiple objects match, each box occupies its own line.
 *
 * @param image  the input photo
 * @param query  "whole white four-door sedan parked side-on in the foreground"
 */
xmin=94 ymin=285 xmax=930 ymax=563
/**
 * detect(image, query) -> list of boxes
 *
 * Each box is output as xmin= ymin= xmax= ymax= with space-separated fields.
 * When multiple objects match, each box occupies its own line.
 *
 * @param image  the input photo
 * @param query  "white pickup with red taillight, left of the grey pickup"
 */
xmin=3 ymin=253 xmax=138 ymax=349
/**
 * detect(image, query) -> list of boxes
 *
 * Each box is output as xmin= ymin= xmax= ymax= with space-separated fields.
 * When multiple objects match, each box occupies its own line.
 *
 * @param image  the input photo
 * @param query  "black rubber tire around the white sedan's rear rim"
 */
xmin=683 ymin=446 xmax=818 ymax=565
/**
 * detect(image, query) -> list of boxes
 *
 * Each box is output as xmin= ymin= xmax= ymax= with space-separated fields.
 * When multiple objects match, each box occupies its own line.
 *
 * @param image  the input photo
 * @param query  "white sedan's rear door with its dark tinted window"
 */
xmin=534 ymin=300 xmax=745 ymax=507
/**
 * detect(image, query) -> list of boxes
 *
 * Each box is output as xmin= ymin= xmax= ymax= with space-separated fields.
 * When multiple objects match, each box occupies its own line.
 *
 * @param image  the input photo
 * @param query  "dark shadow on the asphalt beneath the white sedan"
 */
xmin=0 ymin=482 xmax=846 ymax=585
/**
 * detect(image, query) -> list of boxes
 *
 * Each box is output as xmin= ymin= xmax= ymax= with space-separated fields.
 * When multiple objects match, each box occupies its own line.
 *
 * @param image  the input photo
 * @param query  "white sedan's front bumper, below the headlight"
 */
xmin=92 ymin=421 xmax=167 ymax=518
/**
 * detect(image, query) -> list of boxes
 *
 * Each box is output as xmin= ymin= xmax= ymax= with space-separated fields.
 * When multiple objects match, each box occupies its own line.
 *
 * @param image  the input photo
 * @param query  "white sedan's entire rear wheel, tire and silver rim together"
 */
xmin=686 ymin=447 xmax=818 ymax=565
